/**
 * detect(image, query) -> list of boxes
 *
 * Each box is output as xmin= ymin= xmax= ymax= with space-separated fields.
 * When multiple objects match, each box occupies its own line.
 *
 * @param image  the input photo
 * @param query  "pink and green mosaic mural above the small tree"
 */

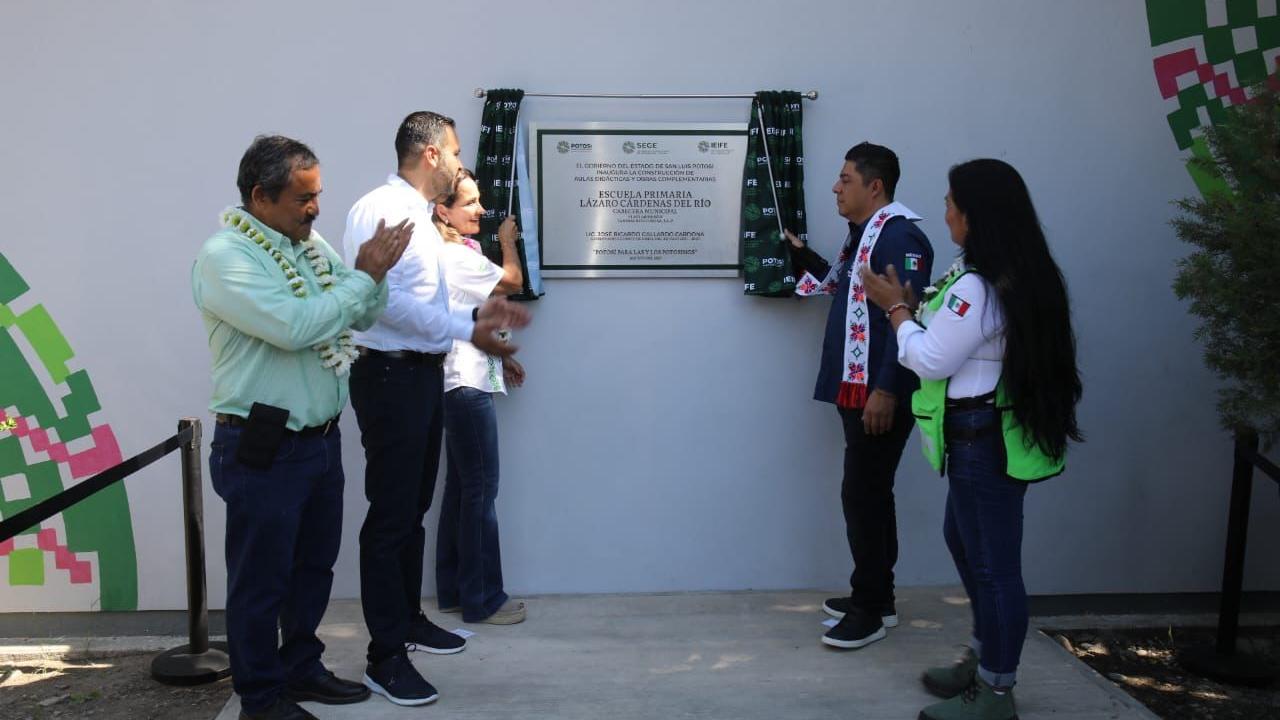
xmin=1147 ymin=0 xmax=1280 ymax=193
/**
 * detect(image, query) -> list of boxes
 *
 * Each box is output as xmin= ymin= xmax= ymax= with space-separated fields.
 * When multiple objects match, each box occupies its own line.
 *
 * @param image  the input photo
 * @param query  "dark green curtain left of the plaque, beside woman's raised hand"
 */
xmin=475 ymin=88 xmax=538 ymax=300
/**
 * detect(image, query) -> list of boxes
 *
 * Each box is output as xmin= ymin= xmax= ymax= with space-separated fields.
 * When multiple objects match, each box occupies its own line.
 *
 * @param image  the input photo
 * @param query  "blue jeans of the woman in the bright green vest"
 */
xmin=942 ymin=407 xmax=1027 ymax=687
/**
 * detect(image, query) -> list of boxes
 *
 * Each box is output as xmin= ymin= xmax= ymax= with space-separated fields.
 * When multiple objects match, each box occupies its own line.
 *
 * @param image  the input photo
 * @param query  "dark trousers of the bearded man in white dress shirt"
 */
xmin=351 ymin=355 xmax=444 ymax=662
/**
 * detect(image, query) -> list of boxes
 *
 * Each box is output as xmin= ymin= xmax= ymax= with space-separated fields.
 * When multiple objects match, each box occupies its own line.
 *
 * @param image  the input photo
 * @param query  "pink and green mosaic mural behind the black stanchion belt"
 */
xmin=0 ymin=254 xmax=138 ymax=610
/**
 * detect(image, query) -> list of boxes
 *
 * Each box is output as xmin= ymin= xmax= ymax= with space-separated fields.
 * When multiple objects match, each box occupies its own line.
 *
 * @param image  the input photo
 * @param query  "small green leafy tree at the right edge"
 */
xmin=1172 ymin=88 xmax=1280 ymax=446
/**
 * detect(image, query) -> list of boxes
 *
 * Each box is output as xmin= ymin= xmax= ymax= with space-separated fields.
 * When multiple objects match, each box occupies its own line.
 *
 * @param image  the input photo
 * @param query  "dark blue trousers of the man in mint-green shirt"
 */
xmin=209 ymin=425 xmax=343 ymax=712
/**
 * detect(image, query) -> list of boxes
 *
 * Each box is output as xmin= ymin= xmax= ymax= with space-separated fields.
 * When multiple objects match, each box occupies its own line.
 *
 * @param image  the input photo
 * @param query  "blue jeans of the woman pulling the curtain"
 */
xmin=435 ymin=387 xmax=507 ymax=623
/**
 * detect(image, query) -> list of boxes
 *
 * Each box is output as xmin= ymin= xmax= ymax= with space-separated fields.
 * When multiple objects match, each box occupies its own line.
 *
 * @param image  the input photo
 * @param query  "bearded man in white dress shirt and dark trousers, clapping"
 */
xmin=343 ymin=111 xmax=529 ymax=706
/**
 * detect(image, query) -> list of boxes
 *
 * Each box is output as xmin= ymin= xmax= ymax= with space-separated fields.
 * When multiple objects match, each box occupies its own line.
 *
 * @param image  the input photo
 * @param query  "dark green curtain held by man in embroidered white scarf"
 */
xmin=741 ymin=90 xmax=809 ymax=297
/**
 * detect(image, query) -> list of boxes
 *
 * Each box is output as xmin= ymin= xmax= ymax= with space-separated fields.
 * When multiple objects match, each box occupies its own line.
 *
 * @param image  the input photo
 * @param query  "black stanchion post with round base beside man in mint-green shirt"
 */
xmin=151 ymin=418 xmax=232 ymax=685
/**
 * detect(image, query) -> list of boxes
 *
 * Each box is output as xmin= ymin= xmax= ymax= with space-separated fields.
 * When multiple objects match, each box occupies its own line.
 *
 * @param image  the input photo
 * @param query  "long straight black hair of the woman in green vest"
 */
xmin=947 ymin=159 xmax=1084 ymax=459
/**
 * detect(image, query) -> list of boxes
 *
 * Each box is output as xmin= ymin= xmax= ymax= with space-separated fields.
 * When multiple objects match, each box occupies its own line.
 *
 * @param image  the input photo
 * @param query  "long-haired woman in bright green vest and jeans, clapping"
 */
xmin=863 ymin=159 xmax=1083 ymax=720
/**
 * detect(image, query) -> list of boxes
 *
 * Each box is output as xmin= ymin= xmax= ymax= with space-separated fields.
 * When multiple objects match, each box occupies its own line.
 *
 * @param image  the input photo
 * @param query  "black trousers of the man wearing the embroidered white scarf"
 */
xmin=837 ymin=404 xmax=914 ymax=612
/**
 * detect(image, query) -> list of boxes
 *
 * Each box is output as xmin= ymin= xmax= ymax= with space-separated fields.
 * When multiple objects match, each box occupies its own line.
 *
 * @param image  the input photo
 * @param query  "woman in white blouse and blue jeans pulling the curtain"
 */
xmin=433 ymin=169 xmax=525 ymax=625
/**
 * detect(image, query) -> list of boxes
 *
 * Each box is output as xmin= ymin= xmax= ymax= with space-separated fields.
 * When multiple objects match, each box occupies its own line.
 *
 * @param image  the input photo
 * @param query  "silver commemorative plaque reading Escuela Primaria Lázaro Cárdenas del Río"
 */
xmin=529 ymin=123 xmax=746 ymax=278
